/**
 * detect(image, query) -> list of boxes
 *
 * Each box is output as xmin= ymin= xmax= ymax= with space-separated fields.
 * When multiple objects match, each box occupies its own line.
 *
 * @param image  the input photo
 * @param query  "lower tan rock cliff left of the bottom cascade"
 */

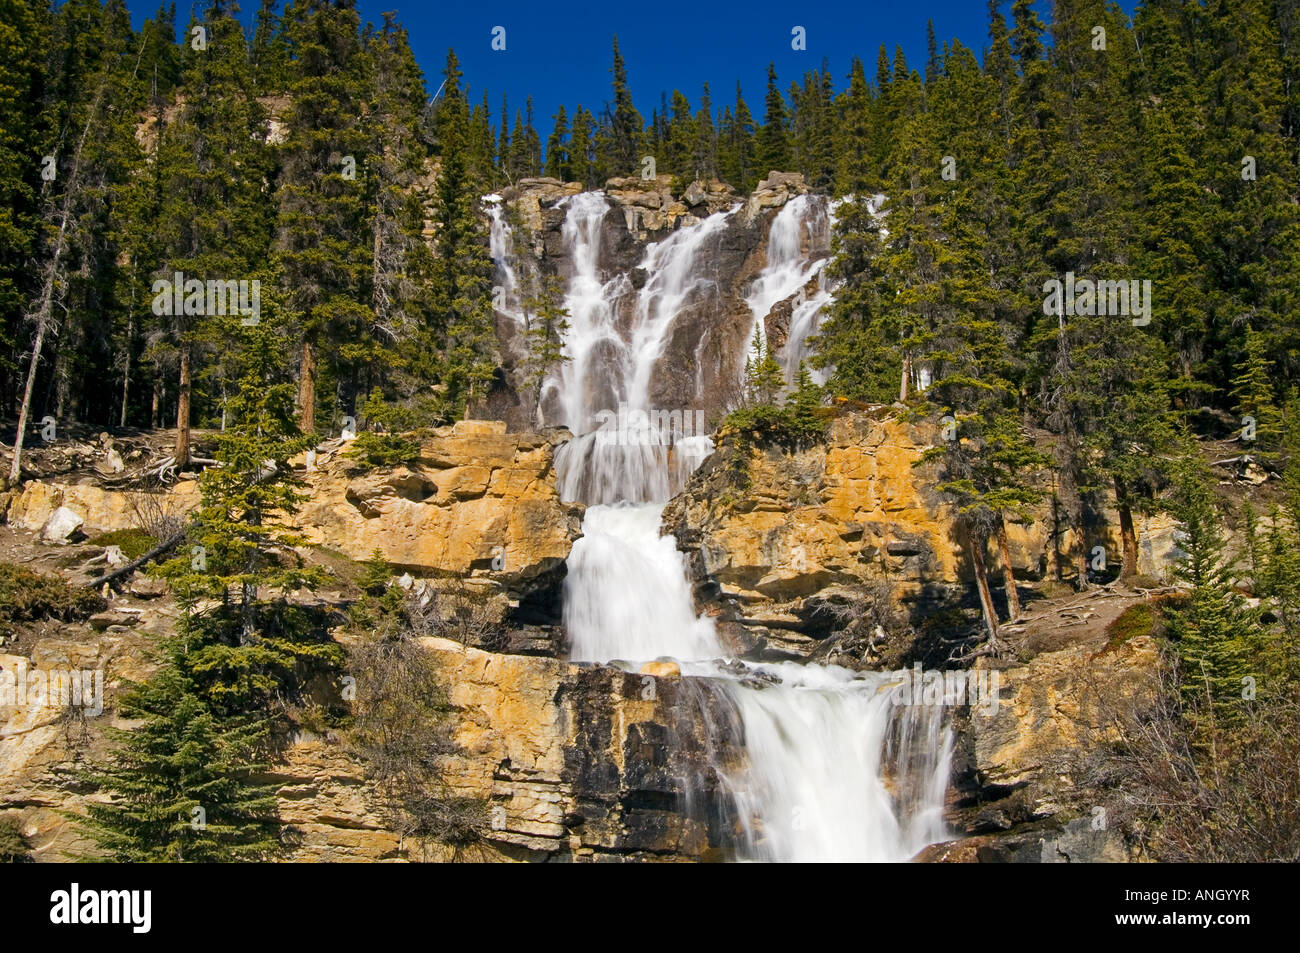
xmin=0 ymin=624 xmax=741 ymax=862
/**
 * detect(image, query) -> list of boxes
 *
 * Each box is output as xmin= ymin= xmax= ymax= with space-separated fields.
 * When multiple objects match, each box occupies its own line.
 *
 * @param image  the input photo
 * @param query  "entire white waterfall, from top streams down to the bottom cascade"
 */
xmin=522 ymin=192 xmax=952 ymax=861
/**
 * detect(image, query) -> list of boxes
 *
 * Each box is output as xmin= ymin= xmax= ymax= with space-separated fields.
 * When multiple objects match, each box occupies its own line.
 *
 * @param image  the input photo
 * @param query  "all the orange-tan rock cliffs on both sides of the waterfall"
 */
xmin=0 ymin=408 xmax=1185 ymax=861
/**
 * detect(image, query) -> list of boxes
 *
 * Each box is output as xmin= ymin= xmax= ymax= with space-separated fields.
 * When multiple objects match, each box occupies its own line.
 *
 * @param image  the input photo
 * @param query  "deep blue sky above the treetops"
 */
xmin=127 ymin=0 xmax=1134 ymax=133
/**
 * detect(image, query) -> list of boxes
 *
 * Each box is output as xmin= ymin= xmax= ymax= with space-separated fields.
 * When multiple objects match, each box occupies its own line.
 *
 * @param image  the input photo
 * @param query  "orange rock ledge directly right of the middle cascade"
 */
xmin=663 ymin=407 xmax=1174 ymax=664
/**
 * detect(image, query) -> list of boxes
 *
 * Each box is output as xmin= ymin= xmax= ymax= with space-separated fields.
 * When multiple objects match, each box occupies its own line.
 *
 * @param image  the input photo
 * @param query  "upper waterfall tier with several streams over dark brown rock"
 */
xmin=489 ymin=176 xmax=833 ymax=503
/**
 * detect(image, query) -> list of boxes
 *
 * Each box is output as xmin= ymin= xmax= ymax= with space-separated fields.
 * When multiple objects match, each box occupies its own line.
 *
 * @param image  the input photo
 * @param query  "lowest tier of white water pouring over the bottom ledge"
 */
xmin=683 ymin=662 xmax=952 ymax=861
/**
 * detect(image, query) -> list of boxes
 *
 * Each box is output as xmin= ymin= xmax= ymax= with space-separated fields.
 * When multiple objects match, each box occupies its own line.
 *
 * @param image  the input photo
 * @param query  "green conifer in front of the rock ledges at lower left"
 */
xmin=81 ymin=323 xmax=343 ymax=861
